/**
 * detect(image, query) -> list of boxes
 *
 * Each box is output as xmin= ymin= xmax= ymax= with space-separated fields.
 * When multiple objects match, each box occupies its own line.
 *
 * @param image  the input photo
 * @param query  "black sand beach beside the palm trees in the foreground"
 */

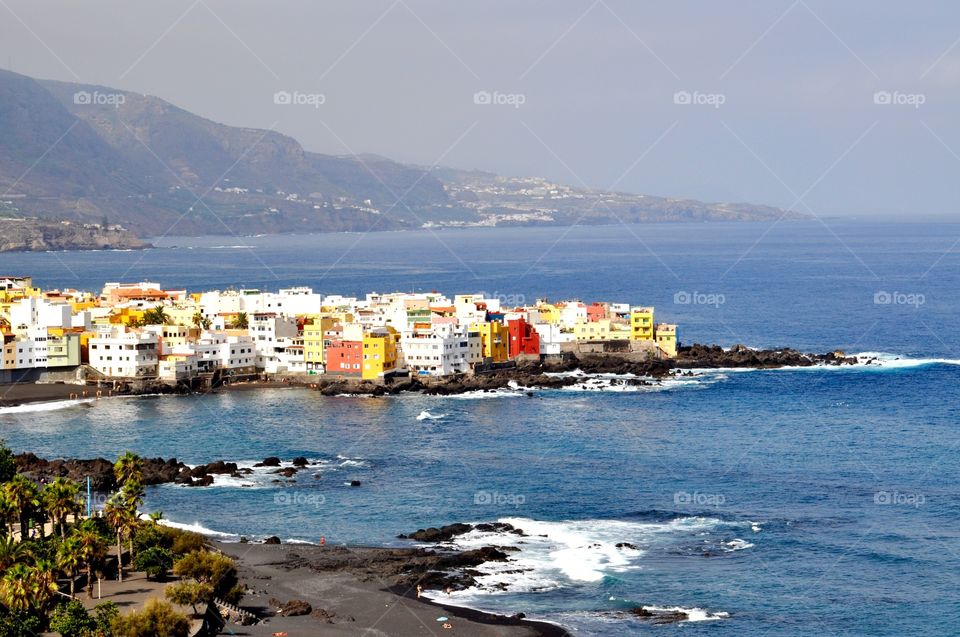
xmin=214 ymin=542 xmax=568 ymax=637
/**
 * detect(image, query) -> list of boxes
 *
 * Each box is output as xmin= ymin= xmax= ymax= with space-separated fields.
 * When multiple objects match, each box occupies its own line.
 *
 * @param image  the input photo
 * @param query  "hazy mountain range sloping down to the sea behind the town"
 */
xmin=0 ymin=70 xmax=796 ymax=241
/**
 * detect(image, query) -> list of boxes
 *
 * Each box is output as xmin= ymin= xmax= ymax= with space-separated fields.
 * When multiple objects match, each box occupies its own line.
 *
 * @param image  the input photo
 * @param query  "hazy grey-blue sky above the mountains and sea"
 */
xmin=0 ymin=0 xmax=960 ymax=217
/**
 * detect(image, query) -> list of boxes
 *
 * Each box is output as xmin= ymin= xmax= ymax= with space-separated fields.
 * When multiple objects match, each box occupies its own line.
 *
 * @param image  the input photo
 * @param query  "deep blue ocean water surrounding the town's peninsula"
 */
xmin=0 ymin=222 xmax=960 ymax=636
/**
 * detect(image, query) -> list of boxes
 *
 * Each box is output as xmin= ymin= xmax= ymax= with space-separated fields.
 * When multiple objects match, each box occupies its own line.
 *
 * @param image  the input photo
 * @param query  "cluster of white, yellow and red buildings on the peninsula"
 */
xmin=0 ymin=277 xmax=677 ymax=384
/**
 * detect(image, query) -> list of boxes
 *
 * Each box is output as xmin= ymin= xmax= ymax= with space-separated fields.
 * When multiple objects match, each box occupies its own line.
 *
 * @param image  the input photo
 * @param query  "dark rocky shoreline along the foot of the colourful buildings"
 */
xmin=0 ymin=344 xmax=858 ymax=408
